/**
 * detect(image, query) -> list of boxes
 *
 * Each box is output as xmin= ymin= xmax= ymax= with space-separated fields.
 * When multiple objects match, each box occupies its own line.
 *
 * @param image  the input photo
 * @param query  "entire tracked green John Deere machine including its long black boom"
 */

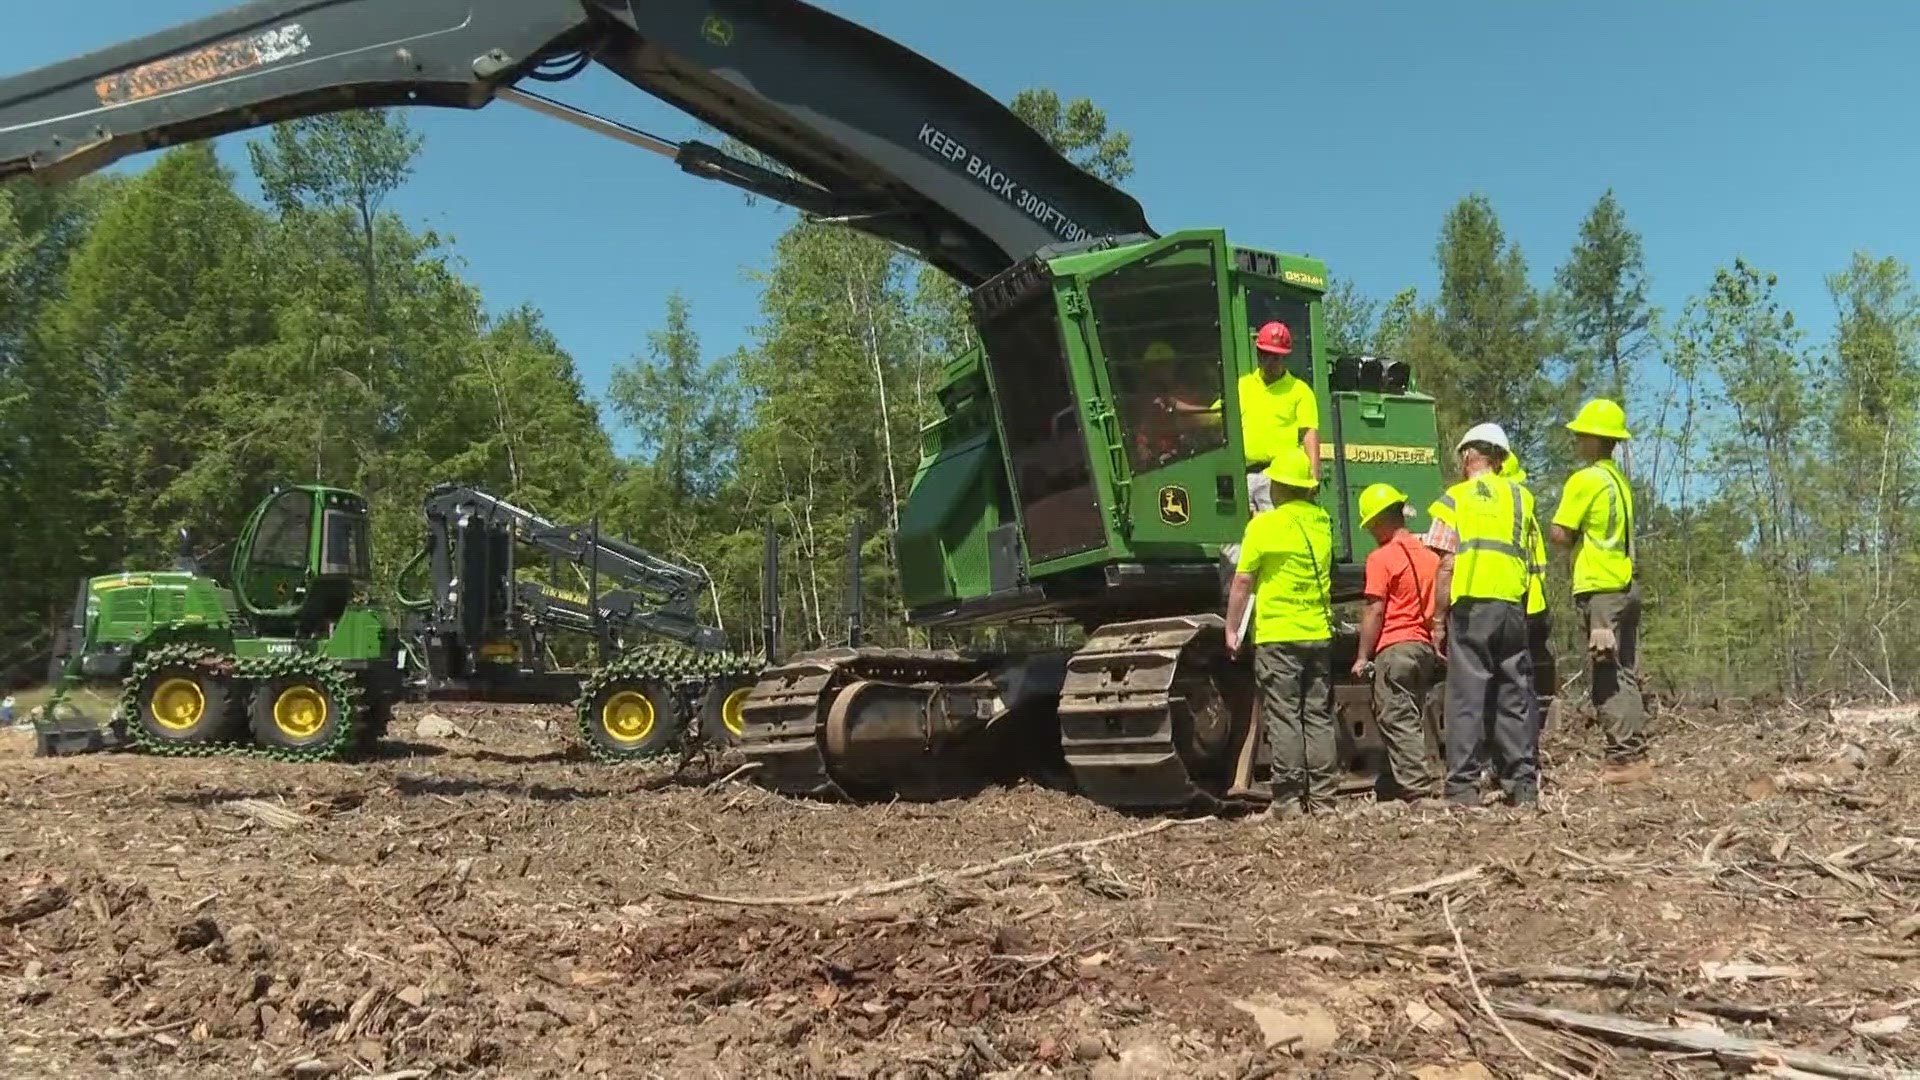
xmin=0 ymin=0 xmax=1440 ymax=805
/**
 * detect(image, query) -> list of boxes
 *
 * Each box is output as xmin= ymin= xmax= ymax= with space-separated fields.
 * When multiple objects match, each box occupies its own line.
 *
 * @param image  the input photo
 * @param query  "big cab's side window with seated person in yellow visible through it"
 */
xmin=1087 ymin=240 xmax=1227 ymax=473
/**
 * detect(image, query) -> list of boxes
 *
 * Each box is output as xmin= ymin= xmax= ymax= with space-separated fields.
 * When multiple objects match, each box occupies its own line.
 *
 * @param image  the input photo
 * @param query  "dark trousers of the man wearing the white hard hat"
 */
xmin=1446 ymin=600 xmax=1540 ymax=803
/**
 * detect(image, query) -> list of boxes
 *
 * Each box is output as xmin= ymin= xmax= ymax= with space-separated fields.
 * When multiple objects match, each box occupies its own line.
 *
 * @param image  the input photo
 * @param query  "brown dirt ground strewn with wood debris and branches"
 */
xmin=0 ymin=691 xmax=1920 ymax=1080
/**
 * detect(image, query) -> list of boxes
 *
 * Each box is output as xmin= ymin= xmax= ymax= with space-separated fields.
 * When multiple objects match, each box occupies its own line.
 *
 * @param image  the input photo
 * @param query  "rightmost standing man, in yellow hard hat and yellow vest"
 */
xmin=1553 ymin=398 xmax=1647 ymax=780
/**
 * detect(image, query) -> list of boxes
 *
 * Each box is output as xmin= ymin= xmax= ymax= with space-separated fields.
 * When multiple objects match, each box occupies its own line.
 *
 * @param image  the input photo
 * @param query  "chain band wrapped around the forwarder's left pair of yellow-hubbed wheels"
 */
xmin=113 ymin=644 xmax=363 ymax=763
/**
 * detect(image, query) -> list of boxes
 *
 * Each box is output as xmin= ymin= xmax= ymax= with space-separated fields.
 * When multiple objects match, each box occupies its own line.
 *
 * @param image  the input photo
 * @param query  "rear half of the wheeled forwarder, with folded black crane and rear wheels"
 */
xmin=401 ymin=484 xmax=758 ymax=761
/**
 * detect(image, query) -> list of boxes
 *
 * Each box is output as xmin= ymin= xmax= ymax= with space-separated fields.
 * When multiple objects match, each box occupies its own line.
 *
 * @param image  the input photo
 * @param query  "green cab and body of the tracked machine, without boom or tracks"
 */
xmin=899 ymin=229 xmax=1440 ymax=623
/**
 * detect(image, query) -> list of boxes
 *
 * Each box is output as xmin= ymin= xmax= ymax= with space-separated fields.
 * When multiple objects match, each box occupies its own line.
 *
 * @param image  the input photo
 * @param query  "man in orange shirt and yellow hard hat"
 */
xmin=1354 ymin=484 xmax=1440 ymax=799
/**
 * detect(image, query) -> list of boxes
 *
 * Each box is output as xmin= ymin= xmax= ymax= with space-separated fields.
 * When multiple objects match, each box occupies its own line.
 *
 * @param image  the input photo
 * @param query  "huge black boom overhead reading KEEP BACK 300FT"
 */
xmin=0 ymin=0 xmax=1152 ymax=286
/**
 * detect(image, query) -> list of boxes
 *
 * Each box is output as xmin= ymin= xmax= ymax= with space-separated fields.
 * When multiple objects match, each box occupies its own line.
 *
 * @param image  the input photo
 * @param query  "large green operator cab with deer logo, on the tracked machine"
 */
xmin=975 ymin=231 xmax=1325 ymax=571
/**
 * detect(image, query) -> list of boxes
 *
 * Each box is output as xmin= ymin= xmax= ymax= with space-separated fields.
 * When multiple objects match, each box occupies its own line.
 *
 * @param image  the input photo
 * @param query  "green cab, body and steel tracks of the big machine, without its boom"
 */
xmin=741 ymin=231 xmax=1442 ymax=807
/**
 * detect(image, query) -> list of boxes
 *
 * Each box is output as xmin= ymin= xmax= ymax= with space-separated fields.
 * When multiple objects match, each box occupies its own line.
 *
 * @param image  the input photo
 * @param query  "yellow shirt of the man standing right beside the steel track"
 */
xmin=1238 ymin=500 xmax=1332 ymax=646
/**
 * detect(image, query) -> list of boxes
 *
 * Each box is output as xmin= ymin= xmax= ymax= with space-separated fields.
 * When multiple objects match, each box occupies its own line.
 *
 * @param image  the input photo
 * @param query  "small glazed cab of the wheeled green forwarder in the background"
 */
xmin=232 ymin=486 xmax=371 ymax=623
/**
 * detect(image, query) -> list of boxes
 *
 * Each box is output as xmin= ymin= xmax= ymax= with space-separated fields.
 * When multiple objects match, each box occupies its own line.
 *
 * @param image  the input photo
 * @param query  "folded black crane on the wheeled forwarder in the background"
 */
xmin=424 ymin=484 xmax=726 ymax=650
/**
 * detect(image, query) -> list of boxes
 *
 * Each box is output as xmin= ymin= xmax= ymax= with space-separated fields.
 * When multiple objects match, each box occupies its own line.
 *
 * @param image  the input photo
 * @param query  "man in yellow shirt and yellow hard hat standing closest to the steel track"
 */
xmin=1227 ymin=446 xmax=1338 ymax=817
